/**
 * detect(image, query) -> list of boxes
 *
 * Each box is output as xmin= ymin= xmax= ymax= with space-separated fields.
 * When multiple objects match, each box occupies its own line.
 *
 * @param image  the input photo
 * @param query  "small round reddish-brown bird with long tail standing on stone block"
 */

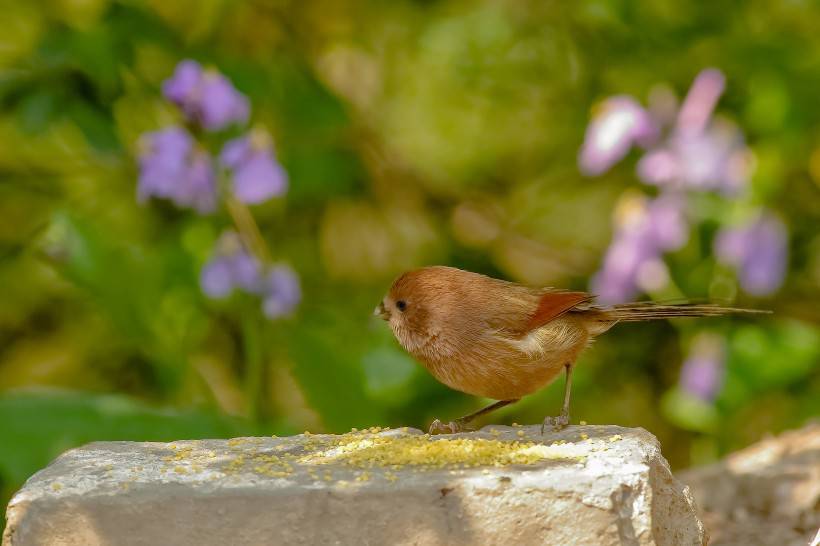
xmin=374 ymin=266 xmax=759 ymax=434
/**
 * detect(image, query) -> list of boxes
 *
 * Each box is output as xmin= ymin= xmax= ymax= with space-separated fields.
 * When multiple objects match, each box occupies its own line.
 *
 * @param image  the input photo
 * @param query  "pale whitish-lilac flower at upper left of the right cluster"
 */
xmin=578 ymin=95 xmax=658 ymax=176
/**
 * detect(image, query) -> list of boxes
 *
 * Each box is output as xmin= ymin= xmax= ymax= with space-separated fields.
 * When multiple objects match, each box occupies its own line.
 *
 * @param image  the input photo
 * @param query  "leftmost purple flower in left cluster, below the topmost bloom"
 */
xmin=137 ymin=127 xmax=217 ymax=214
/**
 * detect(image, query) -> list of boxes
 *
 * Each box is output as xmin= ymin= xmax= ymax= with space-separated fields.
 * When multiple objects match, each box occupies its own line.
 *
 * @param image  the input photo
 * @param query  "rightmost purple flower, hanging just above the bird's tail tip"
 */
xmin=714 ymin=212 xmax=788 ymax=296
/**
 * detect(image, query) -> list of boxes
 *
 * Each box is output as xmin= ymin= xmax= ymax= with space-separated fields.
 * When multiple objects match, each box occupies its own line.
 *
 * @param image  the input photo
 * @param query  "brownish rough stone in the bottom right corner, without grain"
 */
xmin=679 ymin=423 xmax=820 ymax=546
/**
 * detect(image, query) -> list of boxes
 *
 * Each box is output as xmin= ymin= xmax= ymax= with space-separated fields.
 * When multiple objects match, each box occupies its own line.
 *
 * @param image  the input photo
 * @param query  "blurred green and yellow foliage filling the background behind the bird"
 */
xmin=0 ymin=0 xmax=820 ymax=524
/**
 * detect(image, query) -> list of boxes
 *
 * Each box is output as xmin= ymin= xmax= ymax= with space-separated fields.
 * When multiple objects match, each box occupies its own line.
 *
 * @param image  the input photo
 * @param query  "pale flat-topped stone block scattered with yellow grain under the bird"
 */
xmin=3 ymin=426 xmax=705 ymax=546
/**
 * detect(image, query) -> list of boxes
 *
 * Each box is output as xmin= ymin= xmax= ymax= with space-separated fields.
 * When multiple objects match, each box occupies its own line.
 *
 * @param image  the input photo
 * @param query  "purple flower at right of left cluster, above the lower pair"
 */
xmin=220 ymin=130 xmax=288 ymax=205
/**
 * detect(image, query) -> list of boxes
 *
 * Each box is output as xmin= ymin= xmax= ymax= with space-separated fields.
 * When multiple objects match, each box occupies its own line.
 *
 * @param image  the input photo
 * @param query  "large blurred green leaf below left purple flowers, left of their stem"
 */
xmin=45 ymin=213 xmax=205 ymax=389
